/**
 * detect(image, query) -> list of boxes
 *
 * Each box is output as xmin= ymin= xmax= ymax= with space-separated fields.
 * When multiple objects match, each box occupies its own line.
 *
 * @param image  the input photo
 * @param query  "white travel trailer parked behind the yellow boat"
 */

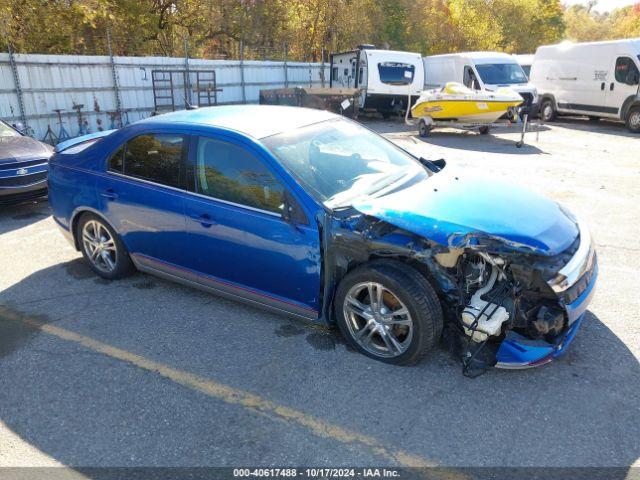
xmin=329 ymin=45 xmax=424 ymax=117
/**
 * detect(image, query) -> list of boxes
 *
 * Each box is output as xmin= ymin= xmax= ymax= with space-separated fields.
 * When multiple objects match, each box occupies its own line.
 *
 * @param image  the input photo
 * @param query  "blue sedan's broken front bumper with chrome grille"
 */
xmin=496 ymin=219 xmax=598 ymax=369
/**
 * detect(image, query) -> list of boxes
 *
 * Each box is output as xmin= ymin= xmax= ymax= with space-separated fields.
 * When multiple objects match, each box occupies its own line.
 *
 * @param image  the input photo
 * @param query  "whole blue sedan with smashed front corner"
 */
xmin=49 ymin=106 xmax=597 ymax=376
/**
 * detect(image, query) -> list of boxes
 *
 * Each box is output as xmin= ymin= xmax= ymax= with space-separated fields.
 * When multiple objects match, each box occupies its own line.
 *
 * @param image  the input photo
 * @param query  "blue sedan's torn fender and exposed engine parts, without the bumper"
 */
xmin=323 ymin=210 xmax=592 ymax=377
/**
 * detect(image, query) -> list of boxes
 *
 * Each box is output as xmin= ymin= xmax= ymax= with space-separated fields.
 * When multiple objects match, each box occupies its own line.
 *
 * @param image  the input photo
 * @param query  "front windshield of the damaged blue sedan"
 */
xmin=262 ymin=119 xmax=428 ymax=208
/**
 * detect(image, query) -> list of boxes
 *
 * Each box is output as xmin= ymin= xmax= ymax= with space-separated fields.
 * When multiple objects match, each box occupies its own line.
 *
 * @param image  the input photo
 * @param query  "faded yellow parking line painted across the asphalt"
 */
xmin=0 ymin=306 xmax=464 ymax=479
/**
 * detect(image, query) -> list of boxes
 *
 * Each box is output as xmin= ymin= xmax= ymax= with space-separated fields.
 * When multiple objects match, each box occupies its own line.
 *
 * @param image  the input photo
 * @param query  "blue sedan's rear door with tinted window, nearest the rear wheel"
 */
xmin=97 ymin=133 xmax=189 ymax=265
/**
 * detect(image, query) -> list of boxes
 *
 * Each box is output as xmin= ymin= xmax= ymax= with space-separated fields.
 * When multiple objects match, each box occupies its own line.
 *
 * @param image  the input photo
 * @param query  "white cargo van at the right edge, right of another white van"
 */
xmin=531 ymin=38 xmax=640 ymax=132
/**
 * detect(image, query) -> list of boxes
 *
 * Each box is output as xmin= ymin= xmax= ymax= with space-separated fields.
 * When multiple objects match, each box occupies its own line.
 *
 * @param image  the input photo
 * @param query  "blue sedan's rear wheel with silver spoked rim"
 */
xmin=76 ymin=213 xmax=133 ymax=280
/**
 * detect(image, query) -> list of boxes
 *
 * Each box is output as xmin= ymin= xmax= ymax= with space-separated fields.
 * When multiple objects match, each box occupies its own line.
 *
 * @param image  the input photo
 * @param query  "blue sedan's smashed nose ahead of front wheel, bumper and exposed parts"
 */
xmin=436 ymin=217 xmax=598 ymax=376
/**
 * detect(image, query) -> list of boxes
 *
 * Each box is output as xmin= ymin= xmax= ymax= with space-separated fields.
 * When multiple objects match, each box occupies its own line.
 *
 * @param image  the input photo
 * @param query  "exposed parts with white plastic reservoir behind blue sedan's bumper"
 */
xmin=445 ymin=252 xmax=566 ymax=376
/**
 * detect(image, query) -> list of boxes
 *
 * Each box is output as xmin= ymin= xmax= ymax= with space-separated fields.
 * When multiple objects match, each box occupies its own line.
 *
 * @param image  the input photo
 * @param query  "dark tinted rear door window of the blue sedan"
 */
xmin=109 ymin=133 xmax=185 ymax=187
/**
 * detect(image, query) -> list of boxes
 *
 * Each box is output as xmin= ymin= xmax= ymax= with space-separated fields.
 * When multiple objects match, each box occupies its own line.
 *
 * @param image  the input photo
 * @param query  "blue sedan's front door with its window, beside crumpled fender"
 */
xmin=185 ymin=136 xmax=321 ymax=318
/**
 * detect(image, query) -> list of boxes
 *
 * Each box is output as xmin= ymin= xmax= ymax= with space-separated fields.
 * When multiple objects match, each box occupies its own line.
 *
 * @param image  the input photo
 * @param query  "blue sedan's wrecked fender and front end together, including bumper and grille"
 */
xmin=323 ymin=202 xmax=598 ymax=377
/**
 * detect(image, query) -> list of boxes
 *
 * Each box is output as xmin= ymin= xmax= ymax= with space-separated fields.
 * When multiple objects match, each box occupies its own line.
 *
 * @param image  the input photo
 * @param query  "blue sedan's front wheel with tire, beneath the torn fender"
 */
xmin=334 ymin=260 xmax=442 ymax=365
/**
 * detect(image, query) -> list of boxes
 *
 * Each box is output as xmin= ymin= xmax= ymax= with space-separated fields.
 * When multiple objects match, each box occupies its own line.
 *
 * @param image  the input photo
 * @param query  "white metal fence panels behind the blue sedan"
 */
xmin=0 ymin=53 xmax=329 ymax=139
